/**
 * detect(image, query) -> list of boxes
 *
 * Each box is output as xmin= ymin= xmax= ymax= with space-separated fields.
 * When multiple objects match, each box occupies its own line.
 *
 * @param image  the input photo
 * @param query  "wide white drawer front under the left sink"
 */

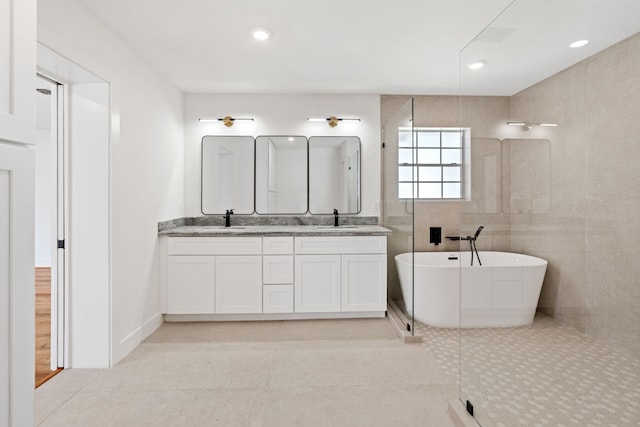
xmin=167 ymin=237 xmax=262 ymax=255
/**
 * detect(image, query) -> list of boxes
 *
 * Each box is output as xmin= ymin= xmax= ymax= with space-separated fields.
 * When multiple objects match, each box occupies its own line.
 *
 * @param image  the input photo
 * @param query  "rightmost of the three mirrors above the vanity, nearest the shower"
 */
xmin=309 ymin=136 xmax=360 ymax=214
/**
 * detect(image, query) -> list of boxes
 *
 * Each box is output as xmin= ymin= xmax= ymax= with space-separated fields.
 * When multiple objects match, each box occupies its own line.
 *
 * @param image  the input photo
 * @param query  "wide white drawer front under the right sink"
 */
xmin=295 ymin=236 xmax=387 ymax=255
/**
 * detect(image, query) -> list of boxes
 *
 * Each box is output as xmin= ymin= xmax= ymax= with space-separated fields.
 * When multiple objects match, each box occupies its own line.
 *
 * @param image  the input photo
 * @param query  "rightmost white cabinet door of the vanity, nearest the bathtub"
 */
xmin=342 ymin=254 xmax=387 ymax=311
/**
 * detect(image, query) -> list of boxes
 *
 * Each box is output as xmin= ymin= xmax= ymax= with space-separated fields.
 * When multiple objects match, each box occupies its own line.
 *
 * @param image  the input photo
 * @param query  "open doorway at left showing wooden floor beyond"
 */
xmin=35 ymin=74 xmax=65 ymax=388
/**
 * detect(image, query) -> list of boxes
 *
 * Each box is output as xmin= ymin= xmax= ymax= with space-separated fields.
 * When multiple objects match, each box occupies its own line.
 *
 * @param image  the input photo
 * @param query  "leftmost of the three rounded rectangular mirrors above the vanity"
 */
xmin=202 ymin=136 xmax=255 ymax=215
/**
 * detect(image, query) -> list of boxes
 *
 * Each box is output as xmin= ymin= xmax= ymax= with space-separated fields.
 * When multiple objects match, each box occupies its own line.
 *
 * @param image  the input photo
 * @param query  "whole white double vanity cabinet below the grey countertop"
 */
xmin=162 ymin=235 xmax=387 ymax=320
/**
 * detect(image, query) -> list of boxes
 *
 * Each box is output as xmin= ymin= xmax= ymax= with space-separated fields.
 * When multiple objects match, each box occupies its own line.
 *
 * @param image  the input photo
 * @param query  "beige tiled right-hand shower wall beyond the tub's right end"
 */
xmin=511 ymin=34 xmax=640 ymax=359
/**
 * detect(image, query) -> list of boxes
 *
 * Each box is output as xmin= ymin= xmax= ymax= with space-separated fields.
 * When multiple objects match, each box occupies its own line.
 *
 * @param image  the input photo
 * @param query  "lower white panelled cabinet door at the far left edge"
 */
xmin=0 ymin=142 xmax=35 ymax=426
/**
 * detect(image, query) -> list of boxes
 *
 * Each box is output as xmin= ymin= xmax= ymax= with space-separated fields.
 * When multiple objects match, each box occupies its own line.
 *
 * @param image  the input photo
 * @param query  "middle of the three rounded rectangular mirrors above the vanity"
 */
xmin=256 ymin=136 xmax=308 ymax=214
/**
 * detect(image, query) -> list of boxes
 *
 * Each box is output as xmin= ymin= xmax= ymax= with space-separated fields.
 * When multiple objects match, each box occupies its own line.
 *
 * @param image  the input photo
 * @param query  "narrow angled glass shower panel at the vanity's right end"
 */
xmin=382 ymin=98 xmax=418 ymax=335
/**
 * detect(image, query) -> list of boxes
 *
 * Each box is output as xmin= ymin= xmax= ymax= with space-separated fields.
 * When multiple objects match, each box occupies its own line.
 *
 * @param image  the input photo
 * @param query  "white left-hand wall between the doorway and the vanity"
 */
xmin=38 ymin=0 xmax=184 ymax=365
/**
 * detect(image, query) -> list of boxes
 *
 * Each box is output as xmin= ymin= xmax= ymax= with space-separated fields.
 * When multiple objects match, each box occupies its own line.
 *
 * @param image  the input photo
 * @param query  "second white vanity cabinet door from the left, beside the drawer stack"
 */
xmin=216 ymin=255 xmax=262 ymax=314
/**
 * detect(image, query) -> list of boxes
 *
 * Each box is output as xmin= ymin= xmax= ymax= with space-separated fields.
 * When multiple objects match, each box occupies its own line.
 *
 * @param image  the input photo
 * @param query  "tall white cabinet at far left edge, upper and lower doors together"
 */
xmin=0 ymin=0 xmax=37 ymax=427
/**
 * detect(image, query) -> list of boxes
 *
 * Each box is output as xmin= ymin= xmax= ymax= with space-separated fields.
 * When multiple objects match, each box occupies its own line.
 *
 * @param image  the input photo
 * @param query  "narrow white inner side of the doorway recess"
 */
xmin=66 ymin=83 xmax=110 ymax=368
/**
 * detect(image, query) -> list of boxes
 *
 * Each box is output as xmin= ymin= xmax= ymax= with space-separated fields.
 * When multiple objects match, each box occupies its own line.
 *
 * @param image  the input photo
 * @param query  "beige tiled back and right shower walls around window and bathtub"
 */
xmin=381 ymin=35 xmax=640 ymax=358
